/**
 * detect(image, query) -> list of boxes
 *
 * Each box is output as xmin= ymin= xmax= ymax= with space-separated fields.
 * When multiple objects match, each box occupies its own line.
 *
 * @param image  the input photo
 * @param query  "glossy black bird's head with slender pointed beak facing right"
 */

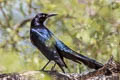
xmin=35 ymin=13 xmax=57 ymax=23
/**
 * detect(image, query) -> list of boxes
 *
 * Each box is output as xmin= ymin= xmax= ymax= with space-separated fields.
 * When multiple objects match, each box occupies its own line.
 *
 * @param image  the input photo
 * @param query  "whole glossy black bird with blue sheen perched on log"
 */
xmin=30 ymin=13 xmax=103 ymax=72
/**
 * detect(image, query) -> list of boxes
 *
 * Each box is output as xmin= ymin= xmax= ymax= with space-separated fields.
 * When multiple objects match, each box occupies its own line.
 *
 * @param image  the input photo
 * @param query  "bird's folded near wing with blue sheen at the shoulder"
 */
xmin=31 ymin=29 xmax=66 ymax=67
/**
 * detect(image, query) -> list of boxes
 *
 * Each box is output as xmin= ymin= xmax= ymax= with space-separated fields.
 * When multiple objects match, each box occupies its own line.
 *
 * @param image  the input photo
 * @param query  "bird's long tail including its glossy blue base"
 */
xmin=56 ymin=39 xmax=103 ymax=69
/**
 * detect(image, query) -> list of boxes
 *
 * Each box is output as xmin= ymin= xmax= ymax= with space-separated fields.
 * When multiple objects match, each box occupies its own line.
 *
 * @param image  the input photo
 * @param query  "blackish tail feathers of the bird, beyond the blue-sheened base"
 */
xmin=63 ymin=51 xmax=103 ymax=69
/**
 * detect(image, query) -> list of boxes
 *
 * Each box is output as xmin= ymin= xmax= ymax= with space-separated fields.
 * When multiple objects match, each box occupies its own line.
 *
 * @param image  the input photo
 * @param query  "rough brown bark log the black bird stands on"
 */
xmin=0 ymin=57 xmax=120 ymax=80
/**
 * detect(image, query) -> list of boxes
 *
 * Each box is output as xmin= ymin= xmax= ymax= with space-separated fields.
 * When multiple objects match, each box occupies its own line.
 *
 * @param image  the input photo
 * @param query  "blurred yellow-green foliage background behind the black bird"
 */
xmin=0 ymin=0 xmax=120 ymax=79
